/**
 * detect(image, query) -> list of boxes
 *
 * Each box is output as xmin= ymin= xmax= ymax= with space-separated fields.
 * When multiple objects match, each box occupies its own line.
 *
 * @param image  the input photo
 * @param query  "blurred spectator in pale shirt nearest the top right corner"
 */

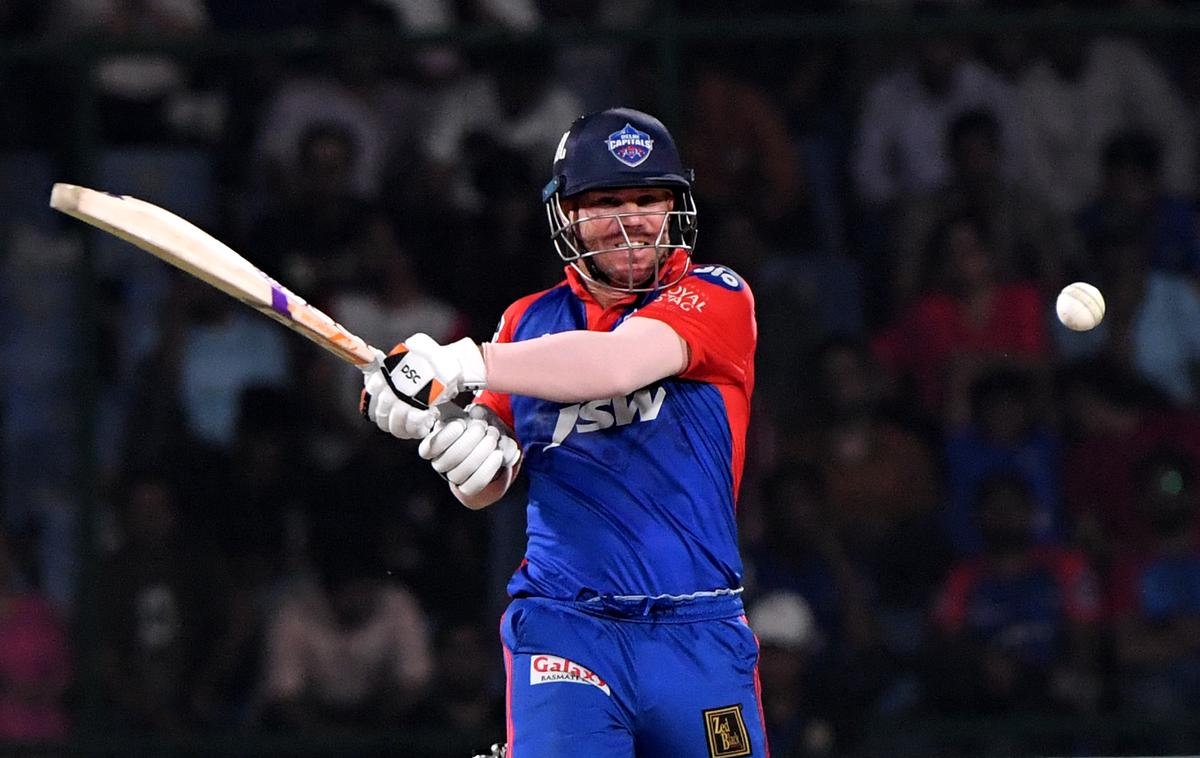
xmin=1018 ymin=14 xmax=1196 ymax=215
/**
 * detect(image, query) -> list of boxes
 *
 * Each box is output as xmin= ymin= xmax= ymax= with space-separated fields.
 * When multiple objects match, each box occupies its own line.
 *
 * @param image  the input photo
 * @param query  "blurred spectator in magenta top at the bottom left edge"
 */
xmin=0 ymin=528 xmax=72 ymax=741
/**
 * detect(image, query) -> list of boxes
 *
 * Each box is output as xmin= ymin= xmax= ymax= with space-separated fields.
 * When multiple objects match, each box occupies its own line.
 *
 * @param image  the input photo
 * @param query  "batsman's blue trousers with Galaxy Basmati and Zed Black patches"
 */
xmin=500 ymin=595 xmax=769 ymax=758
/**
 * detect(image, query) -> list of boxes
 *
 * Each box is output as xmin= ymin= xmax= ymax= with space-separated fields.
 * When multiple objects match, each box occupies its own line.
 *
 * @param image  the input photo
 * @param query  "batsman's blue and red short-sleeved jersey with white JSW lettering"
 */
xmin=476 ymin=265 xmax=757 ymax=600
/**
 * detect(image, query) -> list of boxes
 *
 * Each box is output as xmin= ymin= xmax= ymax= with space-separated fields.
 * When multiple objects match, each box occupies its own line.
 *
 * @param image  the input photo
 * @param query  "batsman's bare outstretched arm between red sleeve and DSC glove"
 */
xmin=484 ymin=318 xmax=688 ymax=403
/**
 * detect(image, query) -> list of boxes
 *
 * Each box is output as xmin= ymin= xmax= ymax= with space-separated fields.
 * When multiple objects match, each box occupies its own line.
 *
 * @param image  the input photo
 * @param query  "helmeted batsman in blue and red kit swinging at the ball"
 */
xmin=362 ymin=108 xmax=768 ymax=758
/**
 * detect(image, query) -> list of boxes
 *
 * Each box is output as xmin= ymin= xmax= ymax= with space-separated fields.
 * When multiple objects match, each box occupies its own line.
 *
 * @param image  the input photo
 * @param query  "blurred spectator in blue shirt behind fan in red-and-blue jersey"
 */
xmin=943 ymin=368 xmax=1066 ymax=555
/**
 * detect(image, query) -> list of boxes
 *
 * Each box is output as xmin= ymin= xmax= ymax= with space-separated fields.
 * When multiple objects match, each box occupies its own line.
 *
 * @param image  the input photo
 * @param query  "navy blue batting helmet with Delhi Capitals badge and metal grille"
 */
xmin=541 ymin=108 xmax=696 ymax=291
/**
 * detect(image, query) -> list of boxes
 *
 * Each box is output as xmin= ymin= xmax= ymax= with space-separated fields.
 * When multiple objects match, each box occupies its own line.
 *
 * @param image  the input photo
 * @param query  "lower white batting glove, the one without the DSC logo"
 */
xmin=416 ymin=405 xmax=521 ymax=497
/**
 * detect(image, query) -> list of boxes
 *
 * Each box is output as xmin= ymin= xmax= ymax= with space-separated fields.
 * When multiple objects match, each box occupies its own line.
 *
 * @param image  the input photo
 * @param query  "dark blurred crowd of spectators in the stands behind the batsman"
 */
xmin=0 ymin=0 xmax=1200 ymax=758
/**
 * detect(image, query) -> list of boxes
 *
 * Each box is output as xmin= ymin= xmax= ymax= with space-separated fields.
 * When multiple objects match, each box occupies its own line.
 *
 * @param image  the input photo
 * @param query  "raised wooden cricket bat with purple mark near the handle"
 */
xmin=50 ymin=182 xmax=446 ymax=408
